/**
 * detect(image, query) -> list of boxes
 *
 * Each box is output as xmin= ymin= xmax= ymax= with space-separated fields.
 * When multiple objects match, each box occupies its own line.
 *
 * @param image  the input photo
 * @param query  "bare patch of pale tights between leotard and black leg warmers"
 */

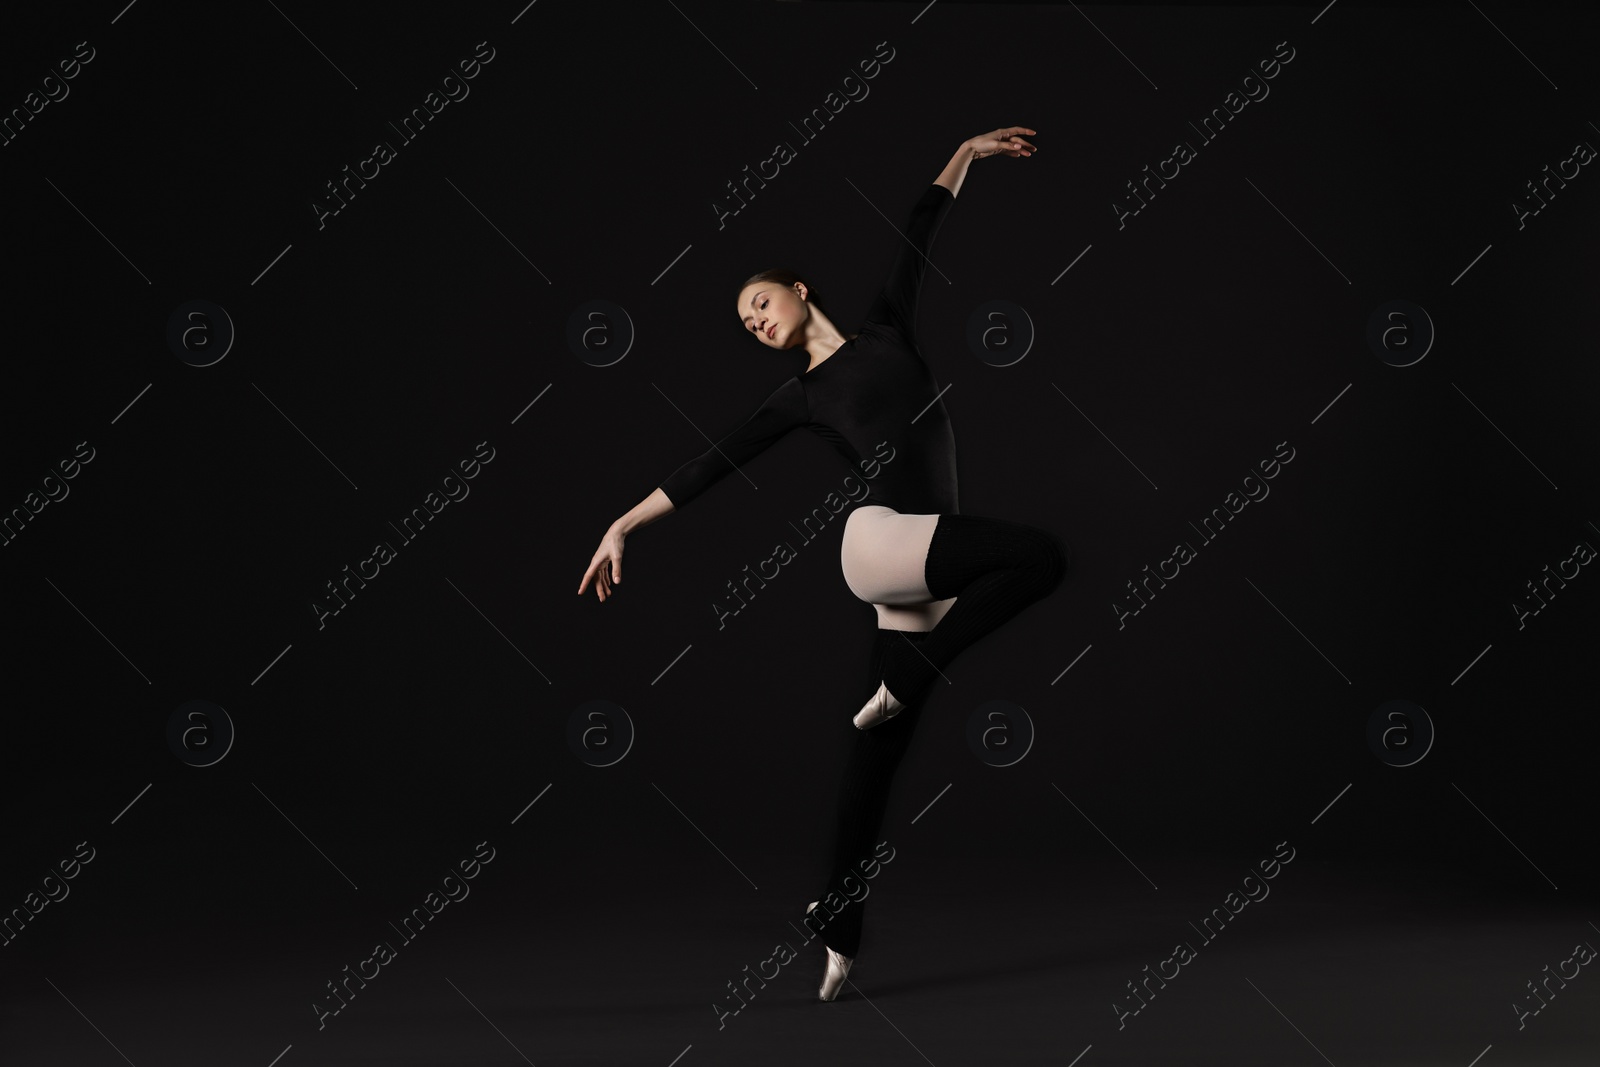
xmin=838 ymin=504 xmax=955 ymax=630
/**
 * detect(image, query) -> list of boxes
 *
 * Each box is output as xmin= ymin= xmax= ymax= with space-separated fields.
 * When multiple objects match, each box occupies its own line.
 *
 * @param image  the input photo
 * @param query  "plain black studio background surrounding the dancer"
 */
xmin=0 ymin=0 xmax=1600 ymax=1067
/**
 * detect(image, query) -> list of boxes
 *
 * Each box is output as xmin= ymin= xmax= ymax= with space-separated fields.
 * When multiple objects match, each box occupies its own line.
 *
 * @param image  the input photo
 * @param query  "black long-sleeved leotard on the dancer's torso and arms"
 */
xmin=661 ymin=186 xmax=957 ymax=515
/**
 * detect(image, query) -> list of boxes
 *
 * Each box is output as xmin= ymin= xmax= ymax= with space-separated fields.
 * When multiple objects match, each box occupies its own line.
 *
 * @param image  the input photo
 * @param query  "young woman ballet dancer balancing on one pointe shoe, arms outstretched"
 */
xmin=578 ymin=126 xmax=1070 ymax=1000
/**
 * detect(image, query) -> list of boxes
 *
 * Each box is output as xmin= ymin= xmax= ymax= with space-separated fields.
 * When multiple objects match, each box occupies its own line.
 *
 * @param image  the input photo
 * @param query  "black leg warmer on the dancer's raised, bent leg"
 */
xmin=883 ymin=515 xmax=1072 ymax=721
